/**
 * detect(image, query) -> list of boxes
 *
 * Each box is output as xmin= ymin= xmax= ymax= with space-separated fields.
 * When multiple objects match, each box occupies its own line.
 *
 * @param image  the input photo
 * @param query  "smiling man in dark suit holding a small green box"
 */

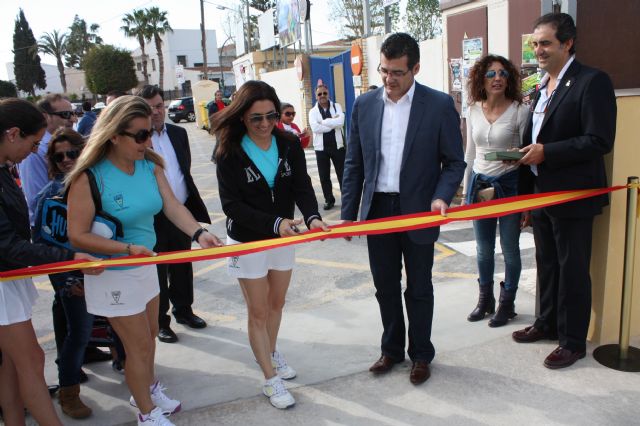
xmin=513 ymin=13 xmax=616 ymax=368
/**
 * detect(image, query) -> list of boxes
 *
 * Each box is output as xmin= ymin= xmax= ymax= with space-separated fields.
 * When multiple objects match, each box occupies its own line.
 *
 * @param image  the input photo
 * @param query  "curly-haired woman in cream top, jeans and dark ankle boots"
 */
xmin=462 ymin=55 xmax=529 ymax=327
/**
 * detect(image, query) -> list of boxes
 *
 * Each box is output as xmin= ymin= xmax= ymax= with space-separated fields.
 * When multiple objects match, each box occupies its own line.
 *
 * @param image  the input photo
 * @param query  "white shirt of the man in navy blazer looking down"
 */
xmin=376 ymin=81 xmax=416 ymax=192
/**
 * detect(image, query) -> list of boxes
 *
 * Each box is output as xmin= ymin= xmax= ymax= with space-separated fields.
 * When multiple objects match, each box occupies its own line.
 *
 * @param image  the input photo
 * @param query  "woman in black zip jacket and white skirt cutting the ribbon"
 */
xmin=212 ymin=81 xmax=328 ymax=409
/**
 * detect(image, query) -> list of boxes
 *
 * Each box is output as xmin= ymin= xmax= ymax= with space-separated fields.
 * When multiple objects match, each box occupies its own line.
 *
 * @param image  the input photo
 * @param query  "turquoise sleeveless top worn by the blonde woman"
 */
xmin=91 ymin=158 xmax=162 ymax=269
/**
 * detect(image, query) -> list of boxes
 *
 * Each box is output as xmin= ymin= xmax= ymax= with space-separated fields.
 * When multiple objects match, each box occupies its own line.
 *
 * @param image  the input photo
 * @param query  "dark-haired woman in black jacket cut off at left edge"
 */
xmin=0 ymin=98 xmax=101 ymax=425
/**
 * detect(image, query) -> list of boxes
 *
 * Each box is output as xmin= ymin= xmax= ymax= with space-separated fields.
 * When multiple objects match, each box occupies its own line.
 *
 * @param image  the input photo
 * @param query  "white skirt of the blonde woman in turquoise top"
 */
xmin=84 ymin=265 xmax=160 ymax=318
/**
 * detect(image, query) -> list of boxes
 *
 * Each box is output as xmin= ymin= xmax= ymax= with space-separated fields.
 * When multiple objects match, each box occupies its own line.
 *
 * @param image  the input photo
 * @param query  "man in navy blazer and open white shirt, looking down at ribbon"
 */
xmin=342 ymin=33 xmax=465 ymax=384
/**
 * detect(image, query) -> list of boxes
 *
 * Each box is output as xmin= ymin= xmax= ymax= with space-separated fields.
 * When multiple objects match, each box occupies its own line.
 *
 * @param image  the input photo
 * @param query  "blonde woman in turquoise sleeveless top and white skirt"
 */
xmin=65 ymin=96 xmax=222 ymax=425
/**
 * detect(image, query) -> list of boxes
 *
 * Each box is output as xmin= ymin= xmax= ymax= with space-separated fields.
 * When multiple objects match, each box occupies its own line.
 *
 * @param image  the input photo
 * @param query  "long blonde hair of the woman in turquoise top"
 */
xmin=64 ymin=95 xmax=164 ymax=188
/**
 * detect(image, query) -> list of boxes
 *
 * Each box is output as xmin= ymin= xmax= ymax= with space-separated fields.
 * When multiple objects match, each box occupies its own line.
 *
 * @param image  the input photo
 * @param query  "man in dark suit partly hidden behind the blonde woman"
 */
xmin=138 ymin=85 xmax=211 ymax=343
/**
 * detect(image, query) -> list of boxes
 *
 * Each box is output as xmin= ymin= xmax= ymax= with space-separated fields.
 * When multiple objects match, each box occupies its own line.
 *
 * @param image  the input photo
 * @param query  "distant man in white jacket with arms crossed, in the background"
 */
xmin=309 ymin=81 xmax=344 ymax=210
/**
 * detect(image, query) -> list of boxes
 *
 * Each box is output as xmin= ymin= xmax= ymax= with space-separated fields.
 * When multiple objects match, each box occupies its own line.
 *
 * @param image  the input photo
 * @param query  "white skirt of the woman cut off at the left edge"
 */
xmin=0 ymin=278 xmax=38 ymax=325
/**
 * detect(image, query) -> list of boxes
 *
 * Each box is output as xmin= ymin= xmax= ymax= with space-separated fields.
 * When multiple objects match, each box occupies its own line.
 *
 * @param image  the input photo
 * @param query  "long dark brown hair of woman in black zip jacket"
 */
xmin=209 ymin=80 xmax=295 ymax=159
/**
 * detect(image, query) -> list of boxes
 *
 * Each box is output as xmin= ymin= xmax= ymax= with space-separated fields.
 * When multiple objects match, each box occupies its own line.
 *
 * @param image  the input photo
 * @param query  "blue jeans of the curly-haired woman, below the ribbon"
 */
xmin=473 ymin=213 xmax=522 ymax=290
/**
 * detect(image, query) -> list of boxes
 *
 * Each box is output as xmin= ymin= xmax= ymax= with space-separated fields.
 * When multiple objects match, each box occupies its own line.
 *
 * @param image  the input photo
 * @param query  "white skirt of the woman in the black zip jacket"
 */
xmin=227 ymin=236 xmax=296 ymax=279
